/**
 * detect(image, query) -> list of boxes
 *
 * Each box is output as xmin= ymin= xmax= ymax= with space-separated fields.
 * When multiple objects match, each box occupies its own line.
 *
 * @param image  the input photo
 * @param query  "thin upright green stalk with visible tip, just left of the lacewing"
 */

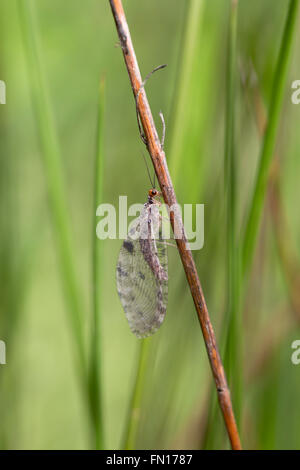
xmin=90 ymin=80 xmax=105 ymax=449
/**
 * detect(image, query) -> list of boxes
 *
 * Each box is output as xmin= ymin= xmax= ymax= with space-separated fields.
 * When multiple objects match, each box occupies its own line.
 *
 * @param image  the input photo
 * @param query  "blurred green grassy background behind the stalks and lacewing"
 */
xmin=0 ymin=0 xmax=300 ymax=449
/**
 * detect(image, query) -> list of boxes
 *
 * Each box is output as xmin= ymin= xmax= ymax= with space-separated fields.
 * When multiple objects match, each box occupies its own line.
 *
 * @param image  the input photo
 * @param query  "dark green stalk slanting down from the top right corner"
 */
xmin=242 ymin=0 xmax=299 ymax=275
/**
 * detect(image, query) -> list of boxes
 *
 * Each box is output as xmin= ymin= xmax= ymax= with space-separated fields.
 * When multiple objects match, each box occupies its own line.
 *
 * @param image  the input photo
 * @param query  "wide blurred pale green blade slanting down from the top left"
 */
xmin=18 ymin=0 xmax=87 ymax=400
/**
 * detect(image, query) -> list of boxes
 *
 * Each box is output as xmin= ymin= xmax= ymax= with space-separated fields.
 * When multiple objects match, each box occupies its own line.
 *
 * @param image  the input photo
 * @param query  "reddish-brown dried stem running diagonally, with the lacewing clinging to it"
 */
xmin=110 ymin=0 xmax=241 ymax=449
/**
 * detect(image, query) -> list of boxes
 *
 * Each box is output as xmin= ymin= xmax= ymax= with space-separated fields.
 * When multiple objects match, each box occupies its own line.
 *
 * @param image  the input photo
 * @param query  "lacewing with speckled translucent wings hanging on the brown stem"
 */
xmin=116 ymin=189 xmax=168 ymax=338
